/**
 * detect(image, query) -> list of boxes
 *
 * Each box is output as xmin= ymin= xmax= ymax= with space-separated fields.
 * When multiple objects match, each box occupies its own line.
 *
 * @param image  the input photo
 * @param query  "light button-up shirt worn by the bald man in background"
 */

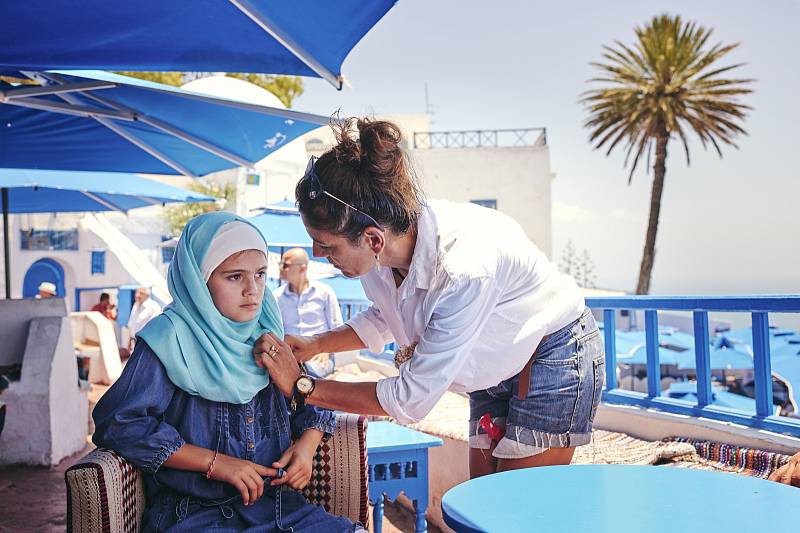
xmin=272 ymin=281 xmax=343 ymax=335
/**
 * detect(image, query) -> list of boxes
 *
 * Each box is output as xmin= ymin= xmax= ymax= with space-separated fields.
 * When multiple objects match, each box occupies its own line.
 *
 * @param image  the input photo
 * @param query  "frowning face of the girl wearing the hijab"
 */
xmin=207 ymin=250 xmax=267 ymax=322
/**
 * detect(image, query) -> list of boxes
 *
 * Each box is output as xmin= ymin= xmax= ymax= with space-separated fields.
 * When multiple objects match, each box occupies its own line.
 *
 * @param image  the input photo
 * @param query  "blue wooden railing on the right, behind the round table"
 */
xmin=586 ymin=295 xmax=800 ymax=436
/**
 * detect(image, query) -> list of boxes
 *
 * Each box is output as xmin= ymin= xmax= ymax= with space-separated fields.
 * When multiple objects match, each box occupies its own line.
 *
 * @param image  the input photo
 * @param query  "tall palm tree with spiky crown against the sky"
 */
xmin=581 ymin=15 xmax=753 ymax=294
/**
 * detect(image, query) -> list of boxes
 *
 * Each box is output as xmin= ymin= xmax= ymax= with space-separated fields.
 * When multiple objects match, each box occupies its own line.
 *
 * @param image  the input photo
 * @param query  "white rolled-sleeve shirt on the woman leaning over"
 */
xmin=348 ymin=201 xmax=585 ymax=423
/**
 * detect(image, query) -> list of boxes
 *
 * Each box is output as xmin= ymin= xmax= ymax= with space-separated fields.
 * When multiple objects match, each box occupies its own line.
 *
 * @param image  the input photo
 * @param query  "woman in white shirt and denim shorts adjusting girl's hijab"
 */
xmin=253 ymin=119 xmax=604 ymax=477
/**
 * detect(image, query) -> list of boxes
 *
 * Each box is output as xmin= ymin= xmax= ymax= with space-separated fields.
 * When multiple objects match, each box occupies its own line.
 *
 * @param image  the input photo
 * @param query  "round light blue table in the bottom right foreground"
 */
xmin=442 ymin=465 xmax=800 ymax=533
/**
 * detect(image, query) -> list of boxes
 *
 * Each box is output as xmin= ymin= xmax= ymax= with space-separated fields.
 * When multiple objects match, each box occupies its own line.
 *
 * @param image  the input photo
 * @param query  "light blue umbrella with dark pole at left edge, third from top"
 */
xmin=0 ymin=168 xmax=215 ymax=298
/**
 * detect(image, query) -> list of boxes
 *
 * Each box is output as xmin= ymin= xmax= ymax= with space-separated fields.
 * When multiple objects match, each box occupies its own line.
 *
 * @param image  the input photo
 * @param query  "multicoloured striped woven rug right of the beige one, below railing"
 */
xmin=664 ymin=437 xmax=790 ymax=479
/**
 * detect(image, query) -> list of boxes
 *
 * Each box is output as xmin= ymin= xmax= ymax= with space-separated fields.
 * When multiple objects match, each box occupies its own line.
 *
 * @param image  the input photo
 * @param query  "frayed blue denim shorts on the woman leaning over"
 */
xmin=469 ymin=309 xmax=605 ymax=459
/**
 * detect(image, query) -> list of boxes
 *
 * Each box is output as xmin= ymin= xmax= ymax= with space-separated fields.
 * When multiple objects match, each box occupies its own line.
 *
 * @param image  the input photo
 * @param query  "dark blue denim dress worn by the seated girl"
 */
xmin=92 ymin=340 xmax=355 ymax=533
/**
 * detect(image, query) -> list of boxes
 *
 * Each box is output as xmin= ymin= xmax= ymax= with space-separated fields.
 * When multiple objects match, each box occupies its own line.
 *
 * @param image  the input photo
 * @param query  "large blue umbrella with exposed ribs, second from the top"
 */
xmin=0 ymin=68 xmax=329 ymax=176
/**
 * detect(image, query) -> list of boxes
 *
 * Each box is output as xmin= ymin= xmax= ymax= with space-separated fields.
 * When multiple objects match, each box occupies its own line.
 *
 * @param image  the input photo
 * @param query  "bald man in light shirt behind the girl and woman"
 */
xmin=273 ymin=248 xmax=342 ymax=377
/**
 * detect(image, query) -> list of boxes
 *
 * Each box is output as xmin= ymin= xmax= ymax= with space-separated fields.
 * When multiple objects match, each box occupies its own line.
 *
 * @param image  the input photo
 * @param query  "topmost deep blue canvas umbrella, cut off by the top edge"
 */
xmin=0 ymin=0 xmax=395 ymax=88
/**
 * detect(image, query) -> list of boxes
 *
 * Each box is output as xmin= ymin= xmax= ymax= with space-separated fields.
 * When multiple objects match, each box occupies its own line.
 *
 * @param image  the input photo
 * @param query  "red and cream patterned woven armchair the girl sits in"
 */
xmin=65 ymin=414 xmax=369 ymax=533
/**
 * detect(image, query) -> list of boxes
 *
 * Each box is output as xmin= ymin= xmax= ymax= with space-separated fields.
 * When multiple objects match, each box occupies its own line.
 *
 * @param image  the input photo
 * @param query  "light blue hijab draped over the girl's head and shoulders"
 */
xmin=139 ymin=211 xmax=283 ymax=404
